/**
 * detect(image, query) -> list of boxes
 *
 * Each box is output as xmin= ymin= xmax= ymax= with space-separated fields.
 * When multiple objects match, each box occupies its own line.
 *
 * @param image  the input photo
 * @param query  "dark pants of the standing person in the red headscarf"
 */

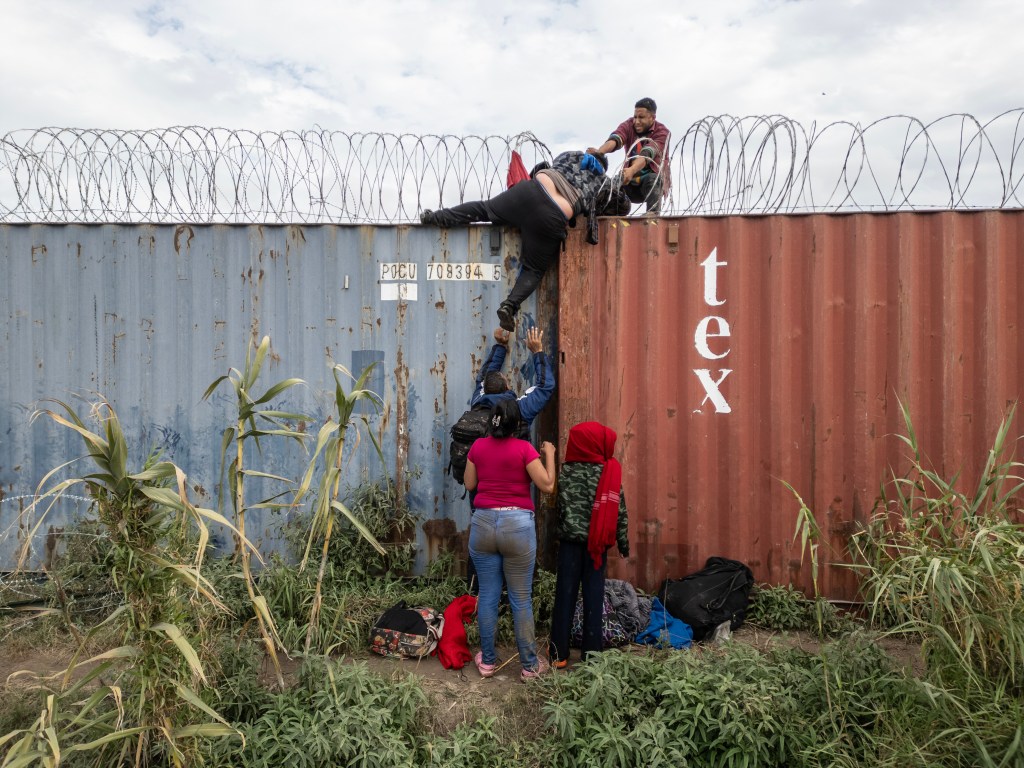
xmin=550 ymin=541 xmax=608 ymax=662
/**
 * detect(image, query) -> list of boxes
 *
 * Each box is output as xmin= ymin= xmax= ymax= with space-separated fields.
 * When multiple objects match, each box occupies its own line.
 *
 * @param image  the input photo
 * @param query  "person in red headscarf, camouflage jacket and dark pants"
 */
xmin=550 ymin=421 xmax=630 ymax=668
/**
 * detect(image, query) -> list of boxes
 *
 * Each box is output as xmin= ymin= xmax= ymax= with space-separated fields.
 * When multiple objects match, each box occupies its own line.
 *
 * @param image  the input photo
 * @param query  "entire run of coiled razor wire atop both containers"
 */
xmin=0 ymin=113 xmax=1024 ymax=223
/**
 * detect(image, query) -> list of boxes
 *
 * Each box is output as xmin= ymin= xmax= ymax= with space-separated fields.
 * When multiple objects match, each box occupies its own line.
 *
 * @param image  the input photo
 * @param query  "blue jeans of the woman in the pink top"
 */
xmin=469 ymin=509 xmax=538 ymax=670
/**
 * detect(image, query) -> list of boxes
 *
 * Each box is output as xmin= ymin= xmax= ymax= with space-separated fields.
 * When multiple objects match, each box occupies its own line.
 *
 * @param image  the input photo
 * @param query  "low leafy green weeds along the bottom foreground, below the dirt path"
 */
xmin=184 ymin=631 xmax=1024 ymax=768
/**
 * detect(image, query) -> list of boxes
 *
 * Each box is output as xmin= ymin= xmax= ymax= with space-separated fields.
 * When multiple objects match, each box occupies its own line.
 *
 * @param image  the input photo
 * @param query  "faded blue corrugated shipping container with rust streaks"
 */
xmin=0 ymin=225 xmax=556 ymax=569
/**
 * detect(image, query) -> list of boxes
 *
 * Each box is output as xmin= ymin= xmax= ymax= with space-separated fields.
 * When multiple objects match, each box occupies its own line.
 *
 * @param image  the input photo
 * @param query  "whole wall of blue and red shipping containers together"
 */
xmin=0 ymin=211 xmax=1024 ymax=598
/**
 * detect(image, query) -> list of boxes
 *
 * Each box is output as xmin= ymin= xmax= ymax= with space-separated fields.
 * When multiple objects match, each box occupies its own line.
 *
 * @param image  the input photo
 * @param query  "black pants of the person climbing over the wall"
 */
xmin=432 ymin=179 xmax=566 ymax=313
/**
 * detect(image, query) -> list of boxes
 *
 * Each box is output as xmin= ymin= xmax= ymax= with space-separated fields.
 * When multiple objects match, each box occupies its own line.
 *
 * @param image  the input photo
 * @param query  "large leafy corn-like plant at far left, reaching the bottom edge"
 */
xmin=0 ymin=400 xmax=242 ymax=766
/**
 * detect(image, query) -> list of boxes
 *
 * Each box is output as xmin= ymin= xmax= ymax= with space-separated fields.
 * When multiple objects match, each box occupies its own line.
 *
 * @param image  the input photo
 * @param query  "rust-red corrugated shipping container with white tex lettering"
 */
xmin=559 ymin=211 xmax=1024 ymax=599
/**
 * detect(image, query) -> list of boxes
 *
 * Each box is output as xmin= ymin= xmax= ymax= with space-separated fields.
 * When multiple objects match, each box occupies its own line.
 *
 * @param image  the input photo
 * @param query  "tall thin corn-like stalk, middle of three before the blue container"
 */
xmin=203 ymin=336 xmax=308 ymax=687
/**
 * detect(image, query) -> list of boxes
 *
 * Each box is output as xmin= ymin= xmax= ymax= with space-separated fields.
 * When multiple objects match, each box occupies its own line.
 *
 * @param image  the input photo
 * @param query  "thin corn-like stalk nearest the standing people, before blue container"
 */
xmin=299 ymin=364 xmax=390 ymax=654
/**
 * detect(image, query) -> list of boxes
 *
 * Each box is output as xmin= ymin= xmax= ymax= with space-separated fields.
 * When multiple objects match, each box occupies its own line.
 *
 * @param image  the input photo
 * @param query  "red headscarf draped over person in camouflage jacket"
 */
xmin=564 ymin=421 xmax=623 ymax=568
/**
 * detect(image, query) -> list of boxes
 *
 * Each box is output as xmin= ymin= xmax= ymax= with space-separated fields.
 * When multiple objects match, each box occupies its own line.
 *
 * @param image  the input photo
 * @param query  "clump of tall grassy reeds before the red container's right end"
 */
xmin=854 ymin=402 xmax=1024 ymax=694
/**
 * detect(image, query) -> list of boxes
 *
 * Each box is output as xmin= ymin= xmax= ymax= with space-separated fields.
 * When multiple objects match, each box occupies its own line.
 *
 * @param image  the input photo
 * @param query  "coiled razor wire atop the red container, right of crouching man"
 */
xmin=670 ymin=109 xmax=1024 ymax=214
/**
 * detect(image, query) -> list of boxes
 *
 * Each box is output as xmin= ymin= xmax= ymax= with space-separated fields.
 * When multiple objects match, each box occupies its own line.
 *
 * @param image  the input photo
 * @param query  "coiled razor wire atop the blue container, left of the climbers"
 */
xmin=0 ymin=127 xmax=551 ymax=223
